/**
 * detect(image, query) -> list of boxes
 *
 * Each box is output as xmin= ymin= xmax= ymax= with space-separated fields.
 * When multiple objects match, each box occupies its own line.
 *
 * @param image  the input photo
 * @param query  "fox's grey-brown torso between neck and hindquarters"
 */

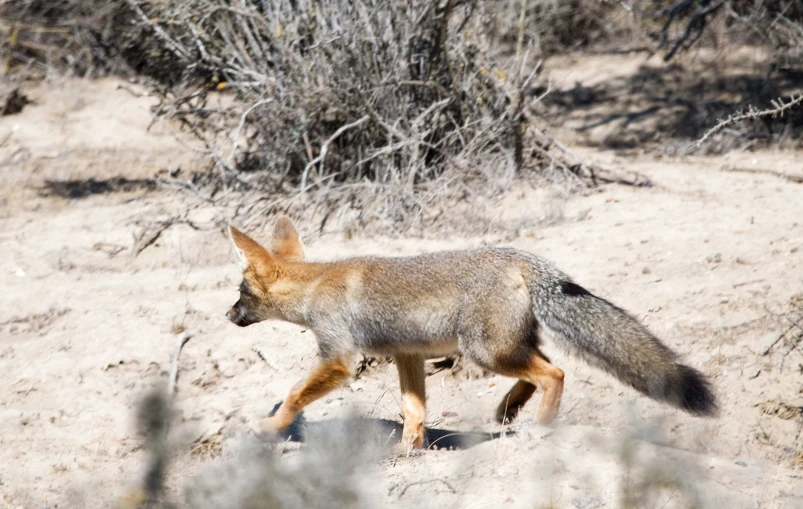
xmin=310 ymin=248 xmax=544 ymax=354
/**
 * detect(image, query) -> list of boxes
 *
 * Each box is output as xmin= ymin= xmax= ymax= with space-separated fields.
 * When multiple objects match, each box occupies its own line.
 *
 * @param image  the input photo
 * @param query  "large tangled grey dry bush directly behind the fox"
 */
xmin=129 ymin=0 xmax=587 ymax=232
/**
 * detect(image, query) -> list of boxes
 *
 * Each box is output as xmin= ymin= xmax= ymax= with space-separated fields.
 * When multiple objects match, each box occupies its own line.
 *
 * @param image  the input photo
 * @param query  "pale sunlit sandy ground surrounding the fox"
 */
xmin=0 ymin=72 xmax=803 ymax=508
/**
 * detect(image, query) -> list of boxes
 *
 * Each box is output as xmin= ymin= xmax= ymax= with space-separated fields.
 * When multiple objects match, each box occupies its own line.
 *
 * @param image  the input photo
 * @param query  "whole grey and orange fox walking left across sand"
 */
xmin=226 ymin=215 xmax=718 ymax=451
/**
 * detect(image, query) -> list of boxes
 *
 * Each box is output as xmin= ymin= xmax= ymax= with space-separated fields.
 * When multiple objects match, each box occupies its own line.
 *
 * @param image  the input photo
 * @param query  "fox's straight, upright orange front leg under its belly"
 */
xmin=395 ymin=355 xmax=426 ymax=451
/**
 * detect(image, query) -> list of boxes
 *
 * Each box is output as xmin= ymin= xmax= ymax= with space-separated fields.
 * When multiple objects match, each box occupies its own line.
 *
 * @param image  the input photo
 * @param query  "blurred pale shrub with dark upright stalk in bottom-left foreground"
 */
xmin=113 ymin=389 xmax=381 ymax=509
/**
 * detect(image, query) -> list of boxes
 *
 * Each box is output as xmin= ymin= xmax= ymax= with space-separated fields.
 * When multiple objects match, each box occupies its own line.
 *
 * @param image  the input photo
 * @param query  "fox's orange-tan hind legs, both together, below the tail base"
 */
xmin=490 ymin=350 xmax=563 ymax=424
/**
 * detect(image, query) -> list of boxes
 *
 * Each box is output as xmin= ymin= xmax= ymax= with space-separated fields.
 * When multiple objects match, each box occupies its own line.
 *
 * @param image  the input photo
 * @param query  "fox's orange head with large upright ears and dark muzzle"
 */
xmin=226 ymin=216 xmax=304 ymax=327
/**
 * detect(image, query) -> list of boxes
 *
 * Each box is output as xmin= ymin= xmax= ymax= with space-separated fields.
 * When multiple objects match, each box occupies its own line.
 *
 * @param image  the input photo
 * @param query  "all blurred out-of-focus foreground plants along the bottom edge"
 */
xmin=102 ymin=389 xmax=740 ymax=509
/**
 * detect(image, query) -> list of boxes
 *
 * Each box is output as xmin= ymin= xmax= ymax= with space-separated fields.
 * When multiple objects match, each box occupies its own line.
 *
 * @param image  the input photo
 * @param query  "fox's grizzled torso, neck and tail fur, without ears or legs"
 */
xmin=230 ymin=248 xmax=716 ymax=415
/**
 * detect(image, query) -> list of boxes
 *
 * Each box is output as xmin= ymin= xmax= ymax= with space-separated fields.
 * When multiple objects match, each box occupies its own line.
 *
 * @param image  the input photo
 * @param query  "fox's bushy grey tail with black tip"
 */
xmin=530 ymin=274 xmax=717 ymax=415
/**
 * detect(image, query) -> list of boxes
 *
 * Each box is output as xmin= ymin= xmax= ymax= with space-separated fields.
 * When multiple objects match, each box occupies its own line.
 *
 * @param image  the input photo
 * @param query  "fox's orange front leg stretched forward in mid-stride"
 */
xmin=258 ymin=358 xmax=350 ymax=433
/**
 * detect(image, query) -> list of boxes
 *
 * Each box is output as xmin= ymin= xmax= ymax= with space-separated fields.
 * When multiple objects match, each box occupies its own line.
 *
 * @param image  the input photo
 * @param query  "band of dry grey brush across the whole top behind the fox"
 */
xmin=0 ymin=0 xmax=803 ymax=233
